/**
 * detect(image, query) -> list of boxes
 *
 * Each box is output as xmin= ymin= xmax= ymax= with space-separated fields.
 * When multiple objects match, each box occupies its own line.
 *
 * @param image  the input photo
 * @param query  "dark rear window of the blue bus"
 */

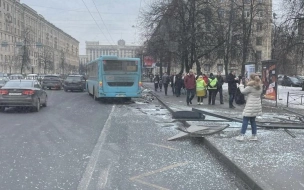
xmin=103 ymin=60 xmax=138 ymax=72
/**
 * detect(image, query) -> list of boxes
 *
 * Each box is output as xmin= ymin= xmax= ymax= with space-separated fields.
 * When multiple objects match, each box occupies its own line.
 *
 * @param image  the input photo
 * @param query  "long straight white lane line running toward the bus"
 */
xmin=77 ymin=105 xmax=115 ymax=190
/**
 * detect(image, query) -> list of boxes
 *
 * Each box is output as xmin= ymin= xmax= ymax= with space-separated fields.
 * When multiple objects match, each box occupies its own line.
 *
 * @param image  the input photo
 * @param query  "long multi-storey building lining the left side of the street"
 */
xmin=0 ymin=0 xmax=79 ymax=74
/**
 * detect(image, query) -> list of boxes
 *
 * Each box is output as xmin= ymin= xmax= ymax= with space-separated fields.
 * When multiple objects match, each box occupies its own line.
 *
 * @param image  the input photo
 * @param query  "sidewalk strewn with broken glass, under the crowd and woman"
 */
xmin=144 ymin=83 xmax=304 ymax=190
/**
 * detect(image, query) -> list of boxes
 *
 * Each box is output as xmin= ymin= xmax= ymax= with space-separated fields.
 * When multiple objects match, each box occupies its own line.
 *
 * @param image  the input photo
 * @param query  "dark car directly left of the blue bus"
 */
xmin=63 ymin=75 xmax=86 ymax=92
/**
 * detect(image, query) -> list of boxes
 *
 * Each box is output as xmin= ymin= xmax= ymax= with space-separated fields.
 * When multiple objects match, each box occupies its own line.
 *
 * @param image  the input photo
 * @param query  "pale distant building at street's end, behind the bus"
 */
xmin=86 ymin=40 xmax=140 ymax=62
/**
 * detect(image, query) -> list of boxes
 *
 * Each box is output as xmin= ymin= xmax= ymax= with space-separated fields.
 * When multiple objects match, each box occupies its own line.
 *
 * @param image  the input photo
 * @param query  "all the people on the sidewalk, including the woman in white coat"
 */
xmin=153 ymin=70 xmax=263 ymax=141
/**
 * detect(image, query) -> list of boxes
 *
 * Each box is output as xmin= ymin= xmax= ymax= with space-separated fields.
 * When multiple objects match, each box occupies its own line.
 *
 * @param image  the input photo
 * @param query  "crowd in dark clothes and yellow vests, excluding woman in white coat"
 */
xmin=151 ymin=70 xmax=240 ymax=108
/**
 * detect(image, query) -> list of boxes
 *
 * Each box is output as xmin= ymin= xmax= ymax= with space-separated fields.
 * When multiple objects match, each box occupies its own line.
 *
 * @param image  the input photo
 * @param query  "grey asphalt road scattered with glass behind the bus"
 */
xmin=0 ymin=90 xmax=249 ymax=190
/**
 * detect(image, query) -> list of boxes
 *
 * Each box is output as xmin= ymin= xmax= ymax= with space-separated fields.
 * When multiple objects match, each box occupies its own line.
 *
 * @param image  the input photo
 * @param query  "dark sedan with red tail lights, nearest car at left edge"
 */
xmin=0 ymin=79 xmax=47 ymax=112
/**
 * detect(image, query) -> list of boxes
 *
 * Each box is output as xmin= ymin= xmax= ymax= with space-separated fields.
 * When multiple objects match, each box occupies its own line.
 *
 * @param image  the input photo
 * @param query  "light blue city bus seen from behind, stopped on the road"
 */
xmin=86 ymin=56 xmax=142 ymax=100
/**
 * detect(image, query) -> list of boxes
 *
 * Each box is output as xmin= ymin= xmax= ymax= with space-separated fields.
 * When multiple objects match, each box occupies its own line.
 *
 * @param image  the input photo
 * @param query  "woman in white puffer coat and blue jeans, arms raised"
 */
xmin=236 ymin=73 xmax=263 ymax=141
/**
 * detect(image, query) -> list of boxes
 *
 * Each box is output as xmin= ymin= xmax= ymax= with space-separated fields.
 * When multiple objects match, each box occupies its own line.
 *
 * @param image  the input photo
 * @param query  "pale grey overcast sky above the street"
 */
xmin=20 ymin=0 xmax=144 ymax=55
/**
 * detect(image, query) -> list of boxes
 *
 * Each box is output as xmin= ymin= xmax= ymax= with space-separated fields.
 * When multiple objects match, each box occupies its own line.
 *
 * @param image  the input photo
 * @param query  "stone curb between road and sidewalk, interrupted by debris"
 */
xmin=144 ymin=84 xmax=272 ymax=190
